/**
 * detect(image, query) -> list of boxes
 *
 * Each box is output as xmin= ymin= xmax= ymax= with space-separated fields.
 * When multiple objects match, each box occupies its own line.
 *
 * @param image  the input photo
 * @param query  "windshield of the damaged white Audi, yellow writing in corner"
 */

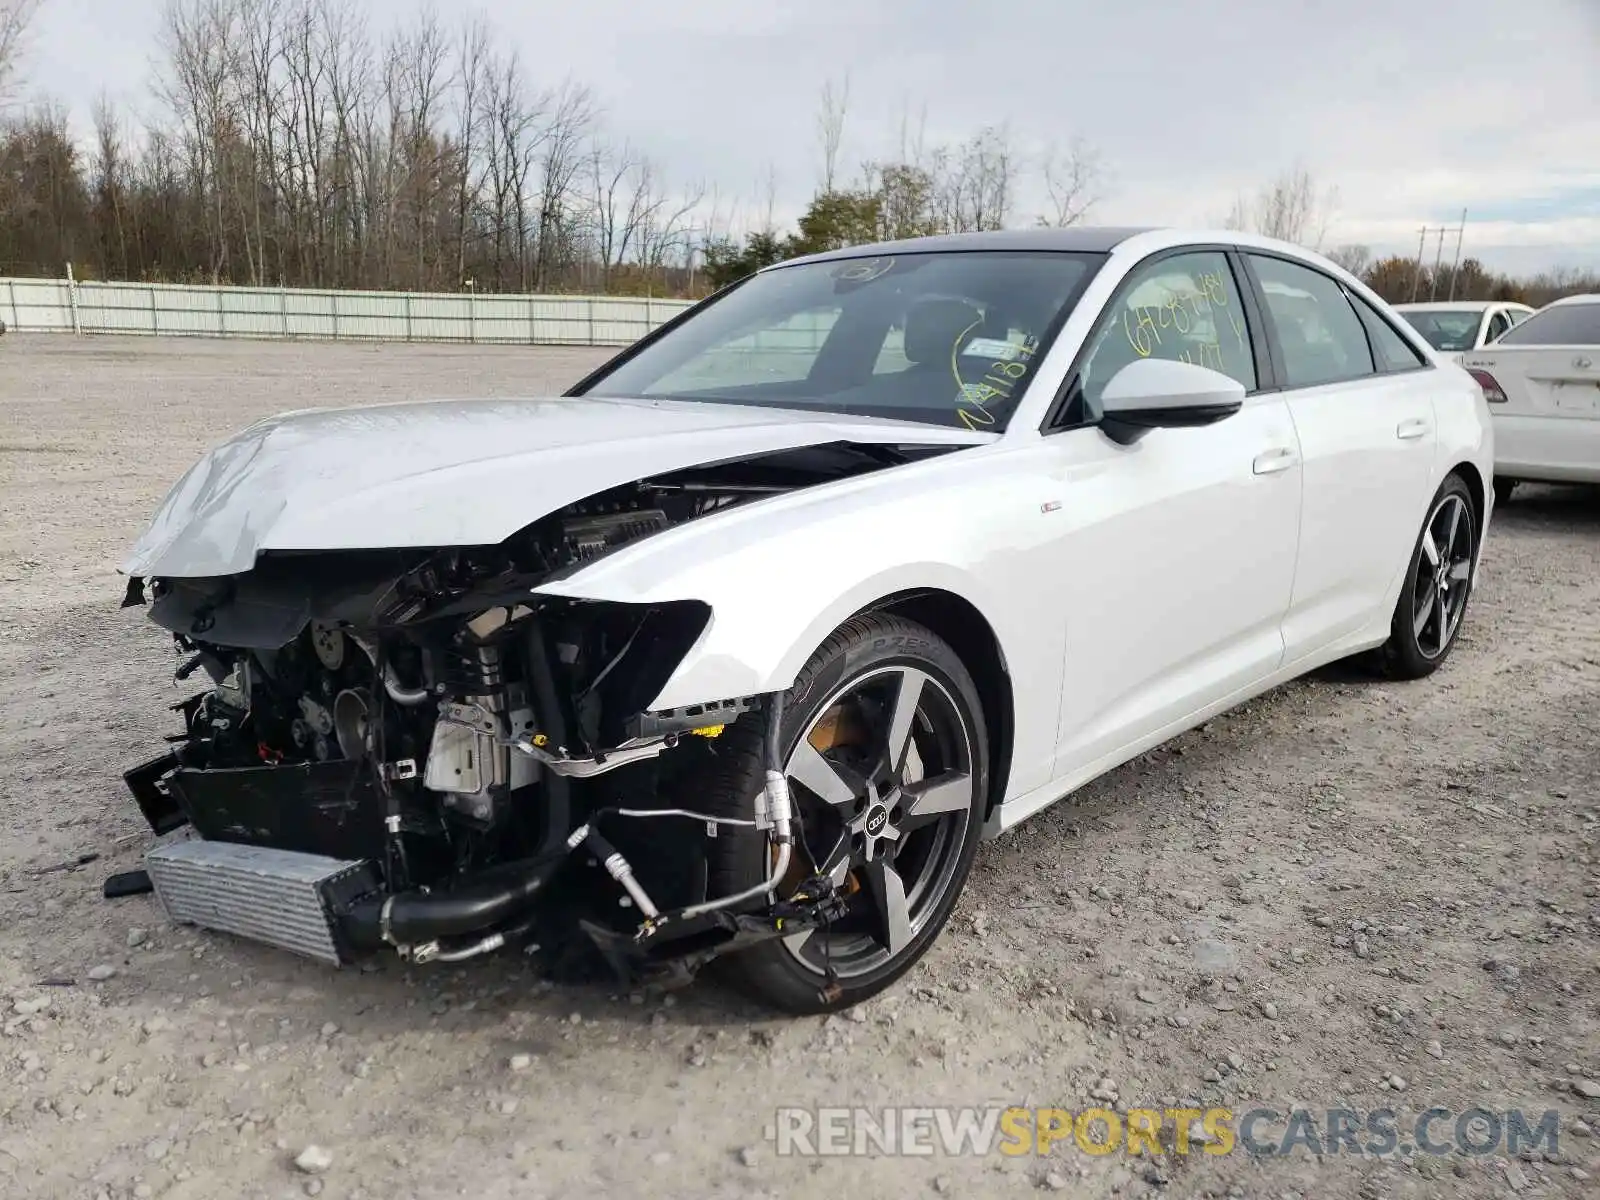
xmin=581 ymin=251 xmax=1106 ymax=432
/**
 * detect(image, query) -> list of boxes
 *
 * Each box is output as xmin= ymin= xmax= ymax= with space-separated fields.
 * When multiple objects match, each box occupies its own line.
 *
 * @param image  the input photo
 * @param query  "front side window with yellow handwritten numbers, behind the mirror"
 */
xmin=1080 ymin=251 xmax=1256 ymax=419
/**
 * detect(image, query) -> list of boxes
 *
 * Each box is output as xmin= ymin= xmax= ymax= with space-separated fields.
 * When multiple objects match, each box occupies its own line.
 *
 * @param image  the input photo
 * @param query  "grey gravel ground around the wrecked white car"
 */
xmin=0 ymin=336 xmax=1600 ymax=1200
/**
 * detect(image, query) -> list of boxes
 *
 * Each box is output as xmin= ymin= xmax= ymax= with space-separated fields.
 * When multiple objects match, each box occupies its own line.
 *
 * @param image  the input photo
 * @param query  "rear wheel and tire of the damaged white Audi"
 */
xmin=1379 ymin=475 xmax=1480 ymax=680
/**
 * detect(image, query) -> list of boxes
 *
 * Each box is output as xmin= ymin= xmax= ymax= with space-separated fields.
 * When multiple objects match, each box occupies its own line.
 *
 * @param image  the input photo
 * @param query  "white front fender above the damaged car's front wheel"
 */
xmin=536 ymin=440 xmax=1067 ymax=803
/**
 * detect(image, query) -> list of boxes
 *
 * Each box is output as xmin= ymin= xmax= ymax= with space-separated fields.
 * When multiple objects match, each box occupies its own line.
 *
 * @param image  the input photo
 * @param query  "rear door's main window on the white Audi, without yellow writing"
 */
xmin=1250 ymin=254 xmax=1376 ymax=387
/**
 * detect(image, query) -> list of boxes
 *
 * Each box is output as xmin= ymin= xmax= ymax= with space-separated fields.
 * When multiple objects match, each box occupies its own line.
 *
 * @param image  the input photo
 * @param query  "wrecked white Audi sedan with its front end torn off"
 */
xmin=123 ymin=229 xmax=1493 ymax=1011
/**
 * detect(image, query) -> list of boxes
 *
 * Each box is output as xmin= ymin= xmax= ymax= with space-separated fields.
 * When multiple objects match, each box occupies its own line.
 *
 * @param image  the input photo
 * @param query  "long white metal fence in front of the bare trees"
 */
xmin=0 ymin=278 xmax=690 ymax=346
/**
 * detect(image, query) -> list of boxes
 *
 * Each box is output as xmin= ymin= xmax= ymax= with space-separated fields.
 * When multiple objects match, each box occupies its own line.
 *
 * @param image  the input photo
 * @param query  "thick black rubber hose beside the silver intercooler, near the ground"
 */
xmin=341 ymin=850 xmax=566 ymax=949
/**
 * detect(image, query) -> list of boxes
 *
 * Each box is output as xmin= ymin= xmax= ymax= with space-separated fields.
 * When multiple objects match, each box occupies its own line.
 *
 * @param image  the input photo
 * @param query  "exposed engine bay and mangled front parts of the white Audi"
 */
xmin=123 ymin=443 xmax=944 ymax=981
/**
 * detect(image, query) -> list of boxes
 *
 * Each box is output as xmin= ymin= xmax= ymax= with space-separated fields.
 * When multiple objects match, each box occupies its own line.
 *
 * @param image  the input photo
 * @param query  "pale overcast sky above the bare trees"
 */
xmin=12 ymin=0 xmax=1600 ymax=270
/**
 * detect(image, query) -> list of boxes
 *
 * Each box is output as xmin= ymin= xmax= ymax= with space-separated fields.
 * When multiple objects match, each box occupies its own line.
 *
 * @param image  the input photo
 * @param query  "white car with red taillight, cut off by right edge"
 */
xmin=1462 ymin=294 xmax=1600 ymax=502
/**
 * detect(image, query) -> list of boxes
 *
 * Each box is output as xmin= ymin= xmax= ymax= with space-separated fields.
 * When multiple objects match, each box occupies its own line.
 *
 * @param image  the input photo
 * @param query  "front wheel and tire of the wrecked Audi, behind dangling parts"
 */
xmin=686 ymin=614 xmax=989 ymax=1014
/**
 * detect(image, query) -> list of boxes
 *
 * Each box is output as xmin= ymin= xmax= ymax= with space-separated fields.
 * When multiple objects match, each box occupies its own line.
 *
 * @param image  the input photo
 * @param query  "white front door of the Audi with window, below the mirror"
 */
xmin=1046 ymin=248 xmax=1301 ymax=787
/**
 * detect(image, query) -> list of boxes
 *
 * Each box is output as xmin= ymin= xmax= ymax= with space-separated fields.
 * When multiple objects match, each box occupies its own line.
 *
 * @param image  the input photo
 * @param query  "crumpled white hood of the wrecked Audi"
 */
xmin=122 ymin=397 xmax=994 ymax=578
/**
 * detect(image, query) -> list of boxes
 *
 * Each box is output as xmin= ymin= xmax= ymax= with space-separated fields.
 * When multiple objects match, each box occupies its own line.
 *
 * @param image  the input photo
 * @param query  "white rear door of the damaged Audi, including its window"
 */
xmin=1246 ymin=251 xmax=1438 ymax=662
